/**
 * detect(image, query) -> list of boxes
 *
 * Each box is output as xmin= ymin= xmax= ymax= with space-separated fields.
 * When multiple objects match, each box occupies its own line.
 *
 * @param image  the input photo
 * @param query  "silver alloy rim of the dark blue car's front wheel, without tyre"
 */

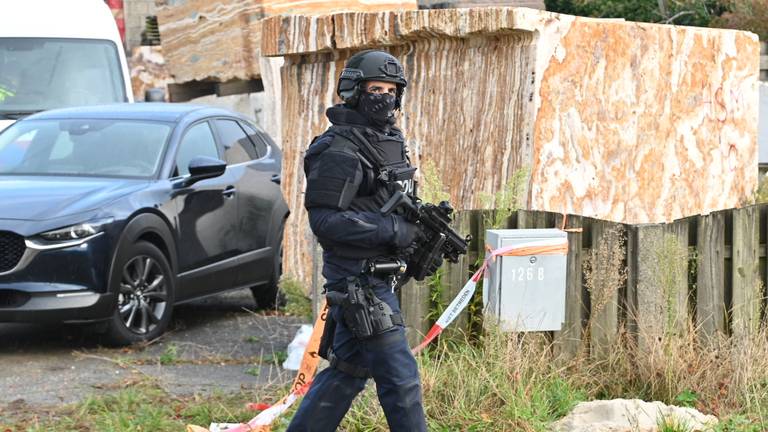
xmin=117 ymin=255 xmax=168 ymax=335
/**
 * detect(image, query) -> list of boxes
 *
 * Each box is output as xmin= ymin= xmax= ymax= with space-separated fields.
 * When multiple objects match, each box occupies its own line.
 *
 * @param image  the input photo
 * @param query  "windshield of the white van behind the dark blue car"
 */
xmin=0 ymin=38 xmax=126 ymax=118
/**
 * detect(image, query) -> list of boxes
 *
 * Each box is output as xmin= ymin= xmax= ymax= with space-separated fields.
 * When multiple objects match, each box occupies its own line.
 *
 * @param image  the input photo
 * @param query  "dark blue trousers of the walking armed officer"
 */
xmin=288 ymin=279 xmax=427 ymax=432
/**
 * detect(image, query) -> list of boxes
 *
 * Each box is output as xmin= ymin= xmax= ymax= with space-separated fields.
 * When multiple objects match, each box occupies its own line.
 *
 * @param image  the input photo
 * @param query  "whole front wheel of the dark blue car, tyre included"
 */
xmin=107 ymin=241 xmax=174 ymax=345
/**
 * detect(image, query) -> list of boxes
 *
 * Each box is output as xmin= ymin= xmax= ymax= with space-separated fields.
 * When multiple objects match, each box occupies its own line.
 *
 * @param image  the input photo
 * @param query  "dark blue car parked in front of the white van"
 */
xmin=0 ymin=104 xmax=288 ymax=344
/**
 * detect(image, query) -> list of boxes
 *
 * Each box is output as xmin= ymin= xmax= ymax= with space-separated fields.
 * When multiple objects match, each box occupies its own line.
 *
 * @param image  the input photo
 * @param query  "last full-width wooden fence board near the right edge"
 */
xmin=731 ymin=206 xmax=762 ymax=337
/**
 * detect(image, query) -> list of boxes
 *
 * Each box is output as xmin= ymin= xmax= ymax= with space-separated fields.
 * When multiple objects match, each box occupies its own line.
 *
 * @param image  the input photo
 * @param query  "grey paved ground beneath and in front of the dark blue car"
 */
xmin=0 ymin=290 xmax=301 ymax=412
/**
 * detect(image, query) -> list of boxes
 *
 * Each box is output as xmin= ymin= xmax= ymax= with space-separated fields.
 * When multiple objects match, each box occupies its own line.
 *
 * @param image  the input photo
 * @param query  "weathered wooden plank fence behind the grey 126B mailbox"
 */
xmin=384 ymin=205 xmax=768 ymax=355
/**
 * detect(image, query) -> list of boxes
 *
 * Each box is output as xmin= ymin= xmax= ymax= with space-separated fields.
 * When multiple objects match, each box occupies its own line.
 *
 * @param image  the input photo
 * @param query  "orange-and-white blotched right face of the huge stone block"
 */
xmin=531 ymin=20 xmax=758 ymax=223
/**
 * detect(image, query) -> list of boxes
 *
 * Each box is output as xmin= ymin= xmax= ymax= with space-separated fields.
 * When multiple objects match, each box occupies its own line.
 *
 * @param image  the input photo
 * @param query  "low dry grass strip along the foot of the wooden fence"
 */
xmin=340 ymin=328 xmax=768 ymax=432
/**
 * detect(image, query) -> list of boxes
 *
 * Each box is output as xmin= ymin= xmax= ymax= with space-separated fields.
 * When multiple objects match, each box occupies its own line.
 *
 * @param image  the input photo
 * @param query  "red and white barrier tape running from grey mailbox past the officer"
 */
xmin=187 ymin=238 xmax=568 ymax=432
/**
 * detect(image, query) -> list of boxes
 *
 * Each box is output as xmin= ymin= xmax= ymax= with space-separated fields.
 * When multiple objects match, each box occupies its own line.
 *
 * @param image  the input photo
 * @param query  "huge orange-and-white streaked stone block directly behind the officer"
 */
xmin=262 ymin=7 xmax=759 ymax=284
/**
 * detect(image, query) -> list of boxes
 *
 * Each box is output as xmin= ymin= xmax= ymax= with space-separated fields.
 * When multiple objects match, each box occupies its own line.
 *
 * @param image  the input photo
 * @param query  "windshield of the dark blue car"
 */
xmin=0 ymin=119 xmax=172 ymax=178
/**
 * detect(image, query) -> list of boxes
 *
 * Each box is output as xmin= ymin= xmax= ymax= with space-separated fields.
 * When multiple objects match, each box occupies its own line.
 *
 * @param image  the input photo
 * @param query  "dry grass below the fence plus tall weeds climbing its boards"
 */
xmin=334 ymin=226 xmax=768 ymax=432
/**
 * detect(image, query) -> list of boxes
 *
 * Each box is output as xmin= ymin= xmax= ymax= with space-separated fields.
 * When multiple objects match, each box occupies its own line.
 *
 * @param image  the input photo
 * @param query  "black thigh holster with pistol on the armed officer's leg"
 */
xmin=326 ymin=276 xmax=403 ymax=339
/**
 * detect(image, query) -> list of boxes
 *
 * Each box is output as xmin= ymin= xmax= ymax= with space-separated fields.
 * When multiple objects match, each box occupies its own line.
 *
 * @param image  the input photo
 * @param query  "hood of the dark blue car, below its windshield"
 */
xmin=0 ymin=176 xmax=149 ymax=221
